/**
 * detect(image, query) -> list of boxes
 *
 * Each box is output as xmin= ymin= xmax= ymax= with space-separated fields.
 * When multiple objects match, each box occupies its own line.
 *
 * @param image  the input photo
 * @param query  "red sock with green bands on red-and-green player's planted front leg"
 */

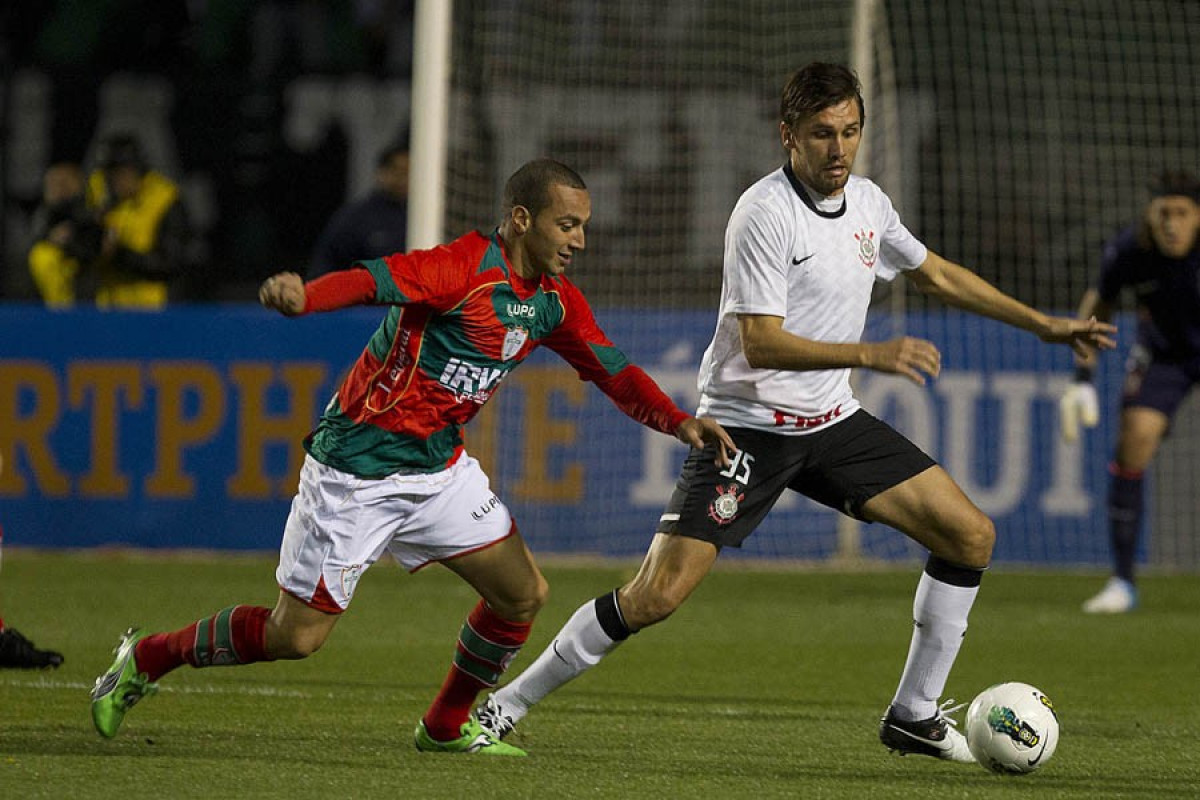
xmin=425 ymin=600 xmax=533 ymax=741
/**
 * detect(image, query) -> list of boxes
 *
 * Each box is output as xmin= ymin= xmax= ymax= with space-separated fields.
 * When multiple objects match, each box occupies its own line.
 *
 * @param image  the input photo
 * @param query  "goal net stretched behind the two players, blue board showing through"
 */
xmin=441 ymin=0 xmax=1200 ymax=564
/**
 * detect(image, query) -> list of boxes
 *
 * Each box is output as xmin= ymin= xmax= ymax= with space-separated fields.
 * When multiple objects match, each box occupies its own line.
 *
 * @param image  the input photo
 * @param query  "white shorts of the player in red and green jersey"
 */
xmin=275 ymin=453 xmax=512 ymax=613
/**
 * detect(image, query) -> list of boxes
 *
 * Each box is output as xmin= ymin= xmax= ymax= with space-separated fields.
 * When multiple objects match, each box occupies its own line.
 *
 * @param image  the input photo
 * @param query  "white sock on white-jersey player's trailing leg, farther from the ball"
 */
xmin=494 ymin=600 xmax=620 ymax=722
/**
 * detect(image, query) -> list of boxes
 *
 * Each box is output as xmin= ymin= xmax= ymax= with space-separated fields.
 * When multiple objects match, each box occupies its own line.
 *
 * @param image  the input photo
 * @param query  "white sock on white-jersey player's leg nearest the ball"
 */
xmin=892 ymin=572 xmax=979 ymax=722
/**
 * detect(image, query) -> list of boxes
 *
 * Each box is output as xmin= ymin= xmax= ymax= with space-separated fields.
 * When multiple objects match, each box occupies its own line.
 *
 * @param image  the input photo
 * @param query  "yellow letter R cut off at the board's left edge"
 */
xmin=0 ymin=361 xmax=71 ymax=498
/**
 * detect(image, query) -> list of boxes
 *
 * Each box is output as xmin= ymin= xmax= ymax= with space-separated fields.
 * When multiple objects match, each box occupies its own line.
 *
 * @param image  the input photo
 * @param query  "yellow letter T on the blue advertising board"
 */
xmin=67 ymin=360 xmax=143 ymax=498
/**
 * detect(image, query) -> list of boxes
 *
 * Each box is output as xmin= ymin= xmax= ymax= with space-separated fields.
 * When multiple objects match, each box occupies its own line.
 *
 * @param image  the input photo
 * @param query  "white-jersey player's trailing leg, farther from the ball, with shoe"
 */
xmin=479 ymin=534 xmax=718 ymax=736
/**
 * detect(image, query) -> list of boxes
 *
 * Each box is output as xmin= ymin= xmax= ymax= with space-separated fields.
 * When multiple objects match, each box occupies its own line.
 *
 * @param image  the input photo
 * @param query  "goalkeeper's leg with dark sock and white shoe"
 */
xmin=1084 ymin=407 xmax=1170 ymax=614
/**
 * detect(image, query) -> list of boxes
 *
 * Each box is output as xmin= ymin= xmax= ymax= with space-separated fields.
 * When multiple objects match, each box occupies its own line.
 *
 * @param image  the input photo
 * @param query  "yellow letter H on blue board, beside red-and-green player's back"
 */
xmin=226 ymin=362 xmax=325 ymax=500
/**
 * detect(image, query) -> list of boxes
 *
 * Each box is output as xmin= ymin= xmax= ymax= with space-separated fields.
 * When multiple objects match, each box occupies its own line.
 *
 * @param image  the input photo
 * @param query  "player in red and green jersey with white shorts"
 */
xmin=91 ymin=160 xmax=733 ymax=756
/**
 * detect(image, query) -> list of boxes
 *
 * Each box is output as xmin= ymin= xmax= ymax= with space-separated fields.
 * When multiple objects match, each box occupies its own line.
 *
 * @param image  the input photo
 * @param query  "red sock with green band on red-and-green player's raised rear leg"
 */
xmin=133 ymin=606 xmax=274 ymax=680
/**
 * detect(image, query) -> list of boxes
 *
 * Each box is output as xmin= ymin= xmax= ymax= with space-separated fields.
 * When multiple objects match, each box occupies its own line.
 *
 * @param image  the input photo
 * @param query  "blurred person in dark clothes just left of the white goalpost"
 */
xmin=308 ymin=142 xmax=408 ymax=278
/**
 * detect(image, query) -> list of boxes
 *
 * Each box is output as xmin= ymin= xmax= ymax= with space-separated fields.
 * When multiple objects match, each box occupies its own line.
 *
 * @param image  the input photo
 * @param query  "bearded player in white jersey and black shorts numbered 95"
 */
xmin=478 ymin=64 xmax=1116 ymax=762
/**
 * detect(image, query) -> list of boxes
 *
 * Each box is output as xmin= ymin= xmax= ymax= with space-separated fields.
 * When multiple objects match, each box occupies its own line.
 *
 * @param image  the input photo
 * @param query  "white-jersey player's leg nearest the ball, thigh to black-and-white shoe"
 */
xmin=863 ymin=467 xmax=996 ymax=762
